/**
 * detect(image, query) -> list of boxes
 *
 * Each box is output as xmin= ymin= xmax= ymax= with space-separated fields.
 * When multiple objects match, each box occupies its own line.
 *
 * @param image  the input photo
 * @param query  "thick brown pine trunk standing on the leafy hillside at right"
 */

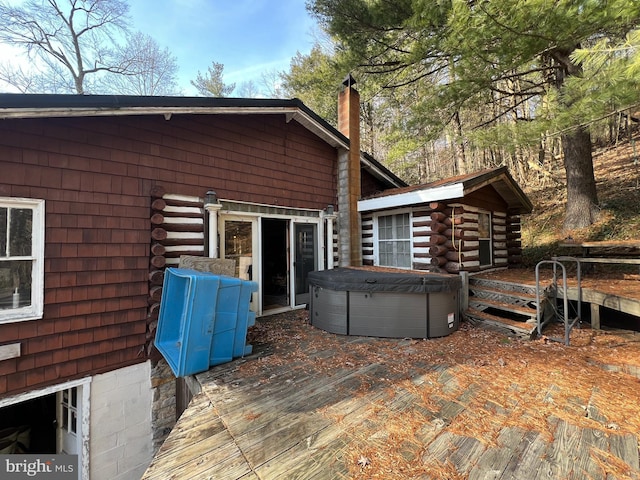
xmin=562 ymin=127 xmax=598 ymax=230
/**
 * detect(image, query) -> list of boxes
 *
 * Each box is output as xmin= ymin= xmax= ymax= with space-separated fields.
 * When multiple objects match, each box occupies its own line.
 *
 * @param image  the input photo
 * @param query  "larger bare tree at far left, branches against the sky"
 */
xmin=0 ymin=0 xmax=136 ymax=94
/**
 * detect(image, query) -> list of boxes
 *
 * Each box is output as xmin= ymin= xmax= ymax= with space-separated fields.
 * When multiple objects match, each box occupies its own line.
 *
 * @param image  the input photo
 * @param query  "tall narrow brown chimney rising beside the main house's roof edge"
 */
xmin=338 ymin=75 xmax=362 ymax=266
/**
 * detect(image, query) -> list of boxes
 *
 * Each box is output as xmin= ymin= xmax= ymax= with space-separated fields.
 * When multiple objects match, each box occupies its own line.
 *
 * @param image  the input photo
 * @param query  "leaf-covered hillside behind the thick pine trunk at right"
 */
xmin=522 ymin=127 xmax=640 ymax=267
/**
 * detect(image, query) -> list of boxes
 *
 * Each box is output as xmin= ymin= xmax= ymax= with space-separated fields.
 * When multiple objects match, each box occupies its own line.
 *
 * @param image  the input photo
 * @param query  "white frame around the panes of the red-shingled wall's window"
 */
xmin=0 ymin=197 xmax=44 ymax=324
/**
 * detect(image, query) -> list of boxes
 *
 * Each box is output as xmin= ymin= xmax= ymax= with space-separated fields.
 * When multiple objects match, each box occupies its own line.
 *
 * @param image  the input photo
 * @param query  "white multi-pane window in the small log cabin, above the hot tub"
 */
xmin=376 ymin=213 xmax=411 ymax=268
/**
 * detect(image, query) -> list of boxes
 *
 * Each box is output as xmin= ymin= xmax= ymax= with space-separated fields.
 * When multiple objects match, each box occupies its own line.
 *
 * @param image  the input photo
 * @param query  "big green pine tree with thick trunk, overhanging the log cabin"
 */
xmin=310 ymin=0 xmax=640 ymax=229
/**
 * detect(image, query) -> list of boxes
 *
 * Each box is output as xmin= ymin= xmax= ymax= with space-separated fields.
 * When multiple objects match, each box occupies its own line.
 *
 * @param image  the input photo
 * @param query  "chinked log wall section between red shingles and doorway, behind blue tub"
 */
xmin=147 ymin=186 xmax=205 ymax=357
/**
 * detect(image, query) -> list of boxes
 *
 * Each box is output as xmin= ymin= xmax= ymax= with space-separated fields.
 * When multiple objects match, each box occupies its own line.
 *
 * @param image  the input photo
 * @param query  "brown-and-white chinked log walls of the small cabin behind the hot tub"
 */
xmin=362 ymin=202 xmax=522 ymax=273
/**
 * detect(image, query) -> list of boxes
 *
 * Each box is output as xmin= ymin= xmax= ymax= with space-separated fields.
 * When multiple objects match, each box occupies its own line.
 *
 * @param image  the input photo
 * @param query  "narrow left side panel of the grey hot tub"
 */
xmin=309 ymin=285 xmax=348 ymax=335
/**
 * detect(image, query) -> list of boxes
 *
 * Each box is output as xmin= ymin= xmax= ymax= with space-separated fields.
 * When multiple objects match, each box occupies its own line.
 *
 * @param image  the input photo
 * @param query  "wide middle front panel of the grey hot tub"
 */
xmin=348 ymin=292 xmax=428 ymax=338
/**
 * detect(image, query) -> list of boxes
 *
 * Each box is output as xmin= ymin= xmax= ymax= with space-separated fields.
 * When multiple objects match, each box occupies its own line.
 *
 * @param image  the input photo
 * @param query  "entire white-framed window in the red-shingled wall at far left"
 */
xmin=0 ymin=197 xmax=44 ymax=323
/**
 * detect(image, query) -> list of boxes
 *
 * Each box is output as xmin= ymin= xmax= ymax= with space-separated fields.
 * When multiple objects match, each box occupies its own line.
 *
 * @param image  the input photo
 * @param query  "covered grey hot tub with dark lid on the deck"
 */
xmin=309 ymin=267 xmax=462 ymax=338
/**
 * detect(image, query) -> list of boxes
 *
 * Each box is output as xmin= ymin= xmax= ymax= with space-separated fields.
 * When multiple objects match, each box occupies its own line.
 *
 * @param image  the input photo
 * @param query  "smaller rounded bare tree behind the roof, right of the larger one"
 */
xmin=101 ymin=32 xmax=179 ymax=95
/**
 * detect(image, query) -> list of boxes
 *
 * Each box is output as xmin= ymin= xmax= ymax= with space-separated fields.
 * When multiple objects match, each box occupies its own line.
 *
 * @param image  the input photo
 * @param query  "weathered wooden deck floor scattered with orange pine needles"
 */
xmin=143 ymin=302 xmax=640 ymax=480
